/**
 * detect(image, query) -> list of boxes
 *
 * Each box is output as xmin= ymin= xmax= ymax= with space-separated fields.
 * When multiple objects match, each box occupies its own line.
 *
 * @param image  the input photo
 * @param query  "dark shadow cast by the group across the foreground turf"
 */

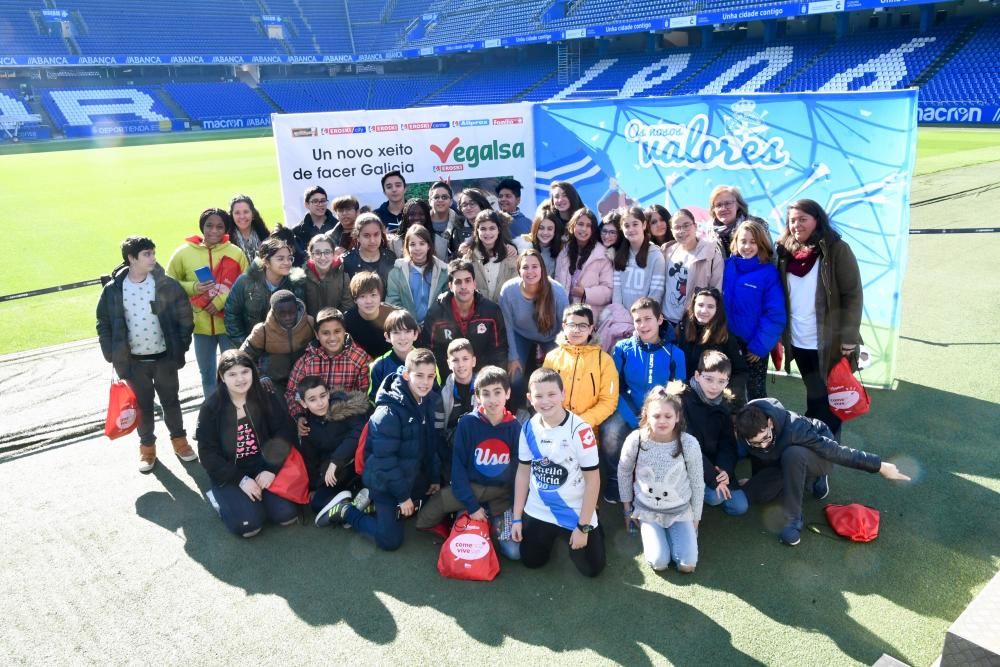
xmin=136 ymin=381 xmax=1000 ymax=665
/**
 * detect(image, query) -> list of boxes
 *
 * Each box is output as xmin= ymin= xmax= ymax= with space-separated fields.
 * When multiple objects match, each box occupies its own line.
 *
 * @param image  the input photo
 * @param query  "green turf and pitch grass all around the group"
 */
xmin=0 ymin=129 xmax=1000 ymax=665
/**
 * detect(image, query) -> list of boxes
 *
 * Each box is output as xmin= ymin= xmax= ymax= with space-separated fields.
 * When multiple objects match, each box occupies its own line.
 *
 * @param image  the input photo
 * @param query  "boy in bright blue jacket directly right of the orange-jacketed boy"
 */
xmin=599 ymin=296 xmax=687 ymax=503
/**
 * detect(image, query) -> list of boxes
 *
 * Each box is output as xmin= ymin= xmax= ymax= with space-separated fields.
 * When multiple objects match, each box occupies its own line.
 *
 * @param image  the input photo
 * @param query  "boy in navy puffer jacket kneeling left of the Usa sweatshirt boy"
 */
xmin=328 ymin=348 xmax=441 ymax=551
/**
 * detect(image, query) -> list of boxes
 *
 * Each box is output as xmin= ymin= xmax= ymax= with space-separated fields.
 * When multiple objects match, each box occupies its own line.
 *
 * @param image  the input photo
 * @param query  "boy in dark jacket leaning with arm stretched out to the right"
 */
xmin=736 ymin=398 xmax=910 ymax=546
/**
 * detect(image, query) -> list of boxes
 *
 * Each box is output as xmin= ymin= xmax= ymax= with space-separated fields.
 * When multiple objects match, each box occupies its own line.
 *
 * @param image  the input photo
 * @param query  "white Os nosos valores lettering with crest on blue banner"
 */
xmin=625 ymin=105 xmax=791 ymax=171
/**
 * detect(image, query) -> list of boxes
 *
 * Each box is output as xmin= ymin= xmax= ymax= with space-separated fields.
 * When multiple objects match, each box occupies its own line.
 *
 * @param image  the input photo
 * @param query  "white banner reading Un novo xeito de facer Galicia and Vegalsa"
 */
xmin=271 ymin=104 xmax=535 ymax=227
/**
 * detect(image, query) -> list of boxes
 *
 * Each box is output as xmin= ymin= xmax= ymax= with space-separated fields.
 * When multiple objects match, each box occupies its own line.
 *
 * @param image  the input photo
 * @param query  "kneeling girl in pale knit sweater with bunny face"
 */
xmin=618 ymin=383 xmax=705 ymax=573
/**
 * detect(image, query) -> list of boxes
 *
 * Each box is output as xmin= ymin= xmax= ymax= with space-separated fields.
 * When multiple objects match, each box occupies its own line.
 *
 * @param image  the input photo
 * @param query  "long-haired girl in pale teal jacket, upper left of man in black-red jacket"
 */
xmin=385 ymin=225 xmax=448 ymax=324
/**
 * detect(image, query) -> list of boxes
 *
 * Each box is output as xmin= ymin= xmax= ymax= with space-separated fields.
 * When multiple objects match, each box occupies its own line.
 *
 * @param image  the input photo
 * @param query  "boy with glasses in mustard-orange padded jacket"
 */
xmin=544 ymin=304 xmax=618 ymax=433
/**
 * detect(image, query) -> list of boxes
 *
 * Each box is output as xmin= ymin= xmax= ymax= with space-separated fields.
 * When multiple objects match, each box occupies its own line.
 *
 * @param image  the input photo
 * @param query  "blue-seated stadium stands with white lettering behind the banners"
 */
xmin=0 ymin=0 xmax=1000 ymax=138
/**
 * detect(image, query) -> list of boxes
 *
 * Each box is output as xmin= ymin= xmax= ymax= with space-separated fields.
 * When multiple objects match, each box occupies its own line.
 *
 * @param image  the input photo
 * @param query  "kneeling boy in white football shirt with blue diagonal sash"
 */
xmin=511 ymin=368 xmax=606 ymax=577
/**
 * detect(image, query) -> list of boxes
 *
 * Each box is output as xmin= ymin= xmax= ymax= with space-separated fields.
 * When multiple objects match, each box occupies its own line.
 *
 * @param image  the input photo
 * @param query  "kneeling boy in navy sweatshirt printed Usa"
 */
xmin=417 ymin=366 xmax=521 ymax=560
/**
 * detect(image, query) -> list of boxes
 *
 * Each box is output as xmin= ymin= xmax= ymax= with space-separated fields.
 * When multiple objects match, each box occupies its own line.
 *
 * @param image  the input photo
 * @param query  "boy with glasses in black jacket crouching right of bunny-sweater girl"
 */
xmin=681 ymin=350 xmax=748 ymax=516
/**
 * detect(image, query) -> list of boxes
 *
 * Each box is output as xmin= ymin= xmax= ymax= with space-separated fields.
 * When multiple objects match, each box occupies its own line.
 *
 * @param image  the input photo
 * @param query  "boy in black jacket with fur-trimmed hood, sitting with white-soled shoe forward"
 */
xmin=295 ymin=375 xmax=368 ymax=527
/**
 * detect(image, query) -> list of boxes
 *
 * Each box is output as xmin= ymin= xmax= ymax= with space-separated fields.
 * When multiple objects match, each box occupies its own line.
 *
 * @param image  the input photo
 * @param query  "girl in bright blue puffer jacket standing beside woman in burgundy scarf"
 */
xmin=722 ymin=220 xmax=788 ymax=400
